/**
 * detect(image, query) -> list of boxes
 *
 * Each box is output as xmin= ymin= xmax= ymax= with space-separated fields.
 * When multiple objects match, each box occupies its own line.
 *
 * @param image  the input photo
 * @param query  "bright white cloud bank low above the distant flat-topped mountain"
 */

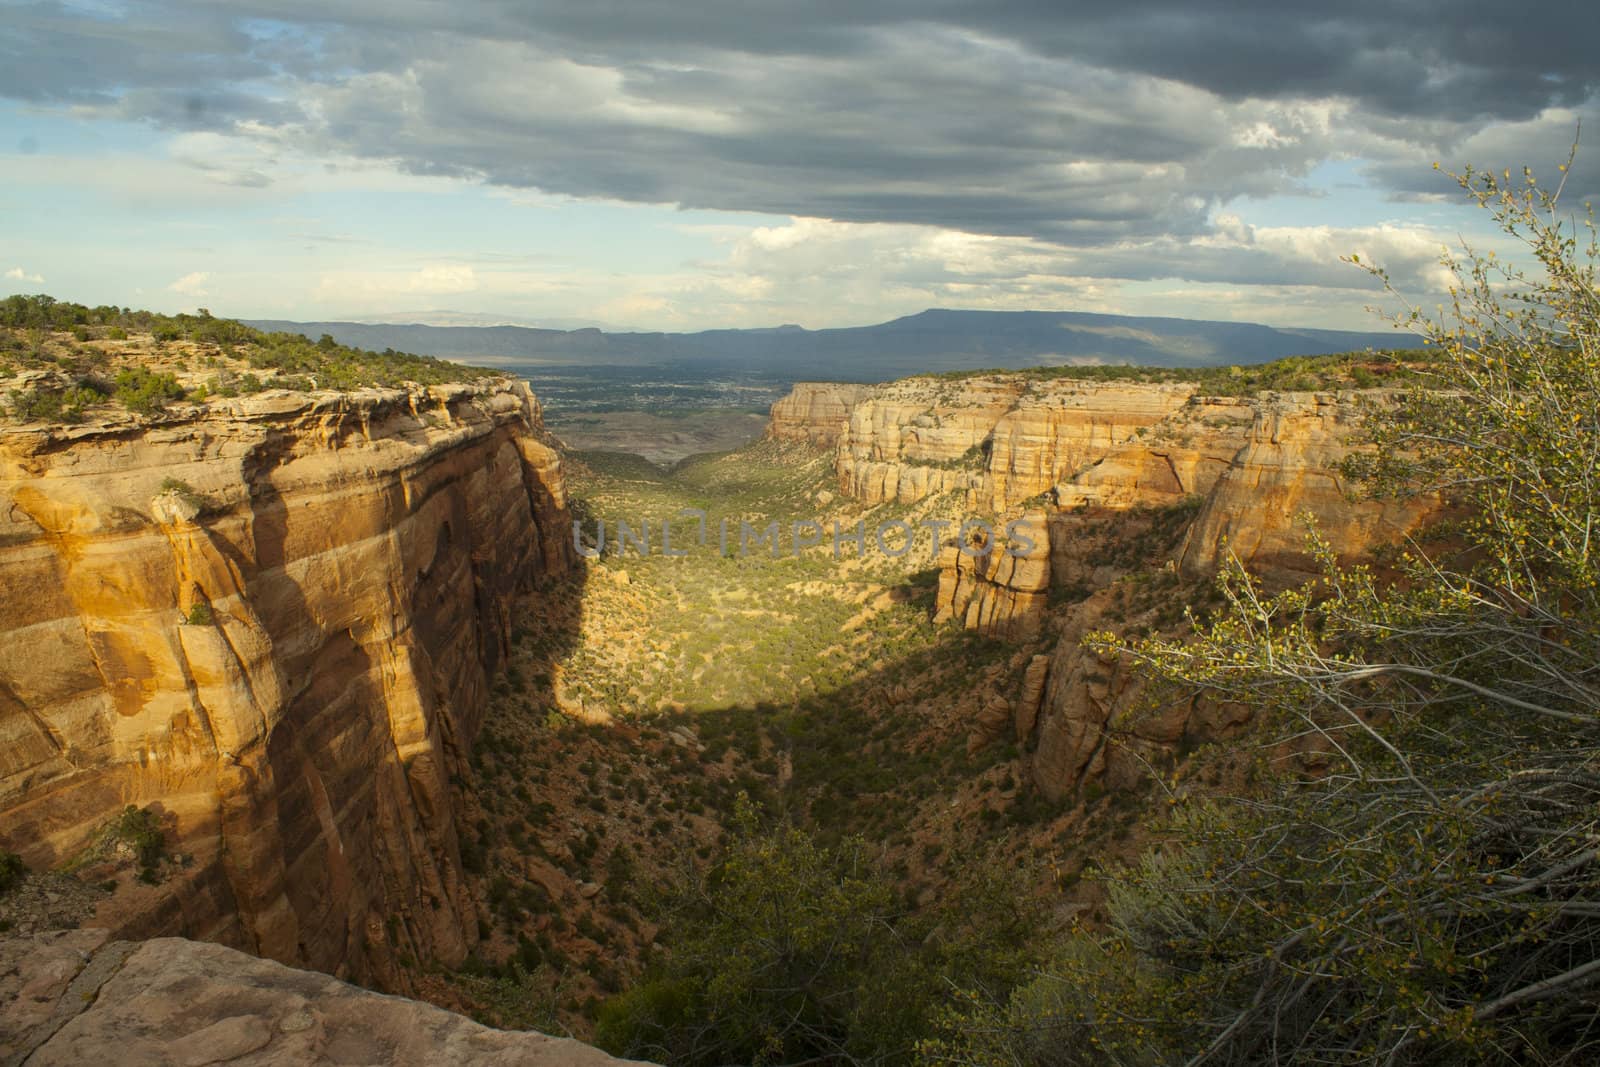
xmin=571 ymin=216 xmax=1451 ymax=330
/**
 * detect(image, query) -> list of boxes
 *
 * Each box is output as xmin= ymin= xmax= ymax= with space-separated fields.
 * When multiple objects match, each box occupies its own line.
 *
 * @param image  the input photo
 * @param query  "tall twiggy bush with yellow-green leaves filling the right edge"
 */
xmin=926 ymin=160 xmax=1600 ymax=1065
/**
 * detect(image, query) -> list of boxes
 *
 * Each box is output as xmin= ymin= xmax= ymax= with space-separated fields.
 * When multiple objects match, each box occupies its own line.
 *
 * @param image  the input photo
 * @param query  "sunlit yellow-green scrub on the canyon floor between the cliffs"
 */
xmin=563 ymin=442 xmax=942 ymax=713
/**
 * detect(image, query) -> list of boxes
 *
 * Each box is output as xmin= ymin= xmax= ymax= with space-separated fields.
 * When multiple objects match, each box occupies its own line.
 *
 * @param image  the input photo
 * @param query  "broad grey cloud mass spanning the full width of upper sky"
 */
xmin=0 ymin=0 xmax=1600 ymax=246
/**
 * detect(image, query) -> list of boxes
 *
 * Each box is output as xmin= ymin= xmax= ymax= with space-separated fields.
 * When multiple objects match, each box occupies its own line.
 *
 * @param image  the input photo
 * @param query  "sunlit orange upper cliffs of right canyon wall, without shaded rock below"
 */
xmin=774 ymin=374 xmax=1430 ymax=637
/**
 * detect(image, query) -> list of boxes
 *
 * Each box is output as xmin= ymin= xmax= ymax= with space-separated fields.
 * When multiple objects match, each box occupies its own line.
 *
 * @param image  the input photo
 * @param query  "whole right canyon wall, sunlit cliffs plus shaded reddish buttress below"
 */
xmin=771 ymin=374 xmax=1438 ymax=800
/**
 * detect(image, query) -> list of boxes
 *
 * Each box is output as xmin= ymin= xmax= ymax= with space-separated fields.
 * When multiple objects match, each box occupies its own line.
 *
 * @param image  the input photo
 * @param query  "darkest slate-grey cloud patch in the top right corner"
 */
xmin=966 ymin=0 xmax=1600 ymax=120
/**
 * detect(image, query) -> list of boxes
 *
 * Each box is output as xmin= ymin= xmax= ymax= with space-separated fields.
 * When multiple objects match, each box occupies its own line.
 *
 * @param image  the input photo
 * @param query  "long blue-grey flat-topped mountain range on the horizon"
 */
xmin=250 ymin=309 xmax=1419 ymax=382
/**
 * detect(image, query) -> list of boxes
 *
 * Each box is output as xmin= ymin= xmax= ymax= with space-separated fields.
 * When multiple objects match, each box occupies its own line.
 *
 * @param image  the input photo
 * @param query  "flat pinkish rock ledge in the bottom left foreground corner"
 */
xmin=0 ymin=931 xmax=646 ymax=1067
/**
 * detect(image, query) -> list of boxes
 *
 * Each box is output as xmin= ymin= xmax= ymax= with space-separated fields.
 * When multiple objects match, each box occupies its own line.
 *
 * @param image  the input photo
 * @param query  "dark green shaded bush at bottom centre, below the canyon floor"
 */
xmin=595 ymin=800 xmax=1038 ymax=1065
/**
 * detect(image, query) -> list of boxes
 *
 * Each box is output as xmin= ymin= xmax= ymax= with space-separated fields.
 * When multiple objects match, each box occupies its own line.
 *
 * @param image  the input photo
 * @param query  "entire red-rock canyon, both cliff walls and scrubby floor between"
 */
xmin=0 ymin=331 xmax=1435 ymax=1048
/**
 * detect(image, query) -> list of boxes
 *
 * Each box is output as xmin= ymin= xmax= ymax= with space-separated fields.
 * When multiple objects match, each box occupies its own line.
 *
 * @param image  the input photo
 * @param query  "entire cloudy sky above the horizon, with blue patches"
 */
xmin=0 ymin=0 xmax=1600 ymax=330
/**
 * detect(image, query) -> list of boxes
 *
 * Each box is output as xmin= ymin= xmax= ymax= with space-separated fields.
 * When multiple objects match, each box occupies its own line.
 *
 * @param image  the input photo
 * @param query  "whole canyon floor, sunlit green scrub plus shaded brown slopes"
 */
xmin=421 ymin=442 xmax=1190 ymax=1035
